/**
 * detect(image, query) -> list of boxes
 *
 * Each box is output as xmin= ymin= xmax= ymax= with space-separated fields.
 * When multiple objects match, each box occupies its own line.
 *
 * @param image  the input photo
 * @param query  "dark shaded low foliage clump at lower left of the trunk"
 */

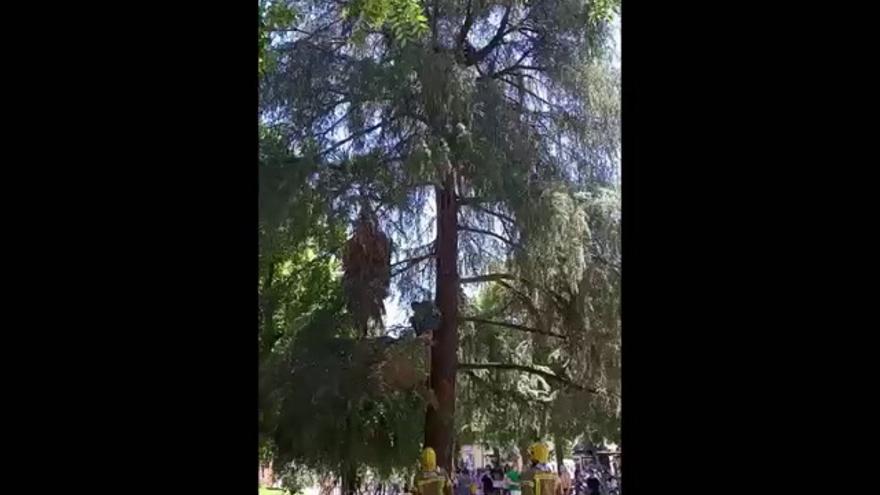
xmin=261 ymin=306 xmax=424 ymax=479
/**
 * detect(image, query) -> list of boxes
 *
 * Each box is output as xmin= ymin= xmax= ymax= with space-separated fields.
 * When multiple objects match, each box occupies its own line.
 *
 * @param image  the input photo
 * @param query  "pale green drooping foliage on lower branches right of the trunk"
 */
xmin=457 ymin=187 xmax=620 ymax=448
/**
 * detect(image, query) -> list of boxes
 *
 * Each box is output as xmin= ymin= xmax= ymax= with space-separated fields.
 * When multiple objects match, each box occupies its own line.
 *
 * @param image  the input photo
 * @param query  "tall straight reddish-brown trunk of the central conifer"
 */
xmin=425 ymin=173 xmax=459 ymax=471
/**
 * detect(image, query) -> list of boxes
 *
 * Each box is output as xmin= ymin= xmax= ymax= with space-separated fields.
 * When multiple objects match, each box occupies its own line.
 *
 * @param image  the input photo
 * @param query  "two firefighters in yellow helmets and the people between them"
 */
xmin=413 ymin=443 xmax=570 ymax=495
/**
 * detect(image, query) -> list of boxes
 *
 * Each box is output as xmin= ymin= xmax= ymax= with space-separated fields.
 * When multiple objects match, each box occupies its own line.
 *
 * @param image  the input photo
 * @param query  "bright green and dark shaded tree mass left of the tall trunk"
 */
xmin=259 ymin=123 xmax=430 ymax=493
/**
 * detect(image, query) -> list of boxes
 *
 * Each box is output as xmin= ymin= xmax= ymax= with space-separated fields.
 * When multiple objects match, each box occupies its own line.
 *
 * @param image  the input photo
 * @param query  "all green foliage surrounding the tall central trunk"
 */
xmin=260 ymin=0 xmax=620 ymax=478
